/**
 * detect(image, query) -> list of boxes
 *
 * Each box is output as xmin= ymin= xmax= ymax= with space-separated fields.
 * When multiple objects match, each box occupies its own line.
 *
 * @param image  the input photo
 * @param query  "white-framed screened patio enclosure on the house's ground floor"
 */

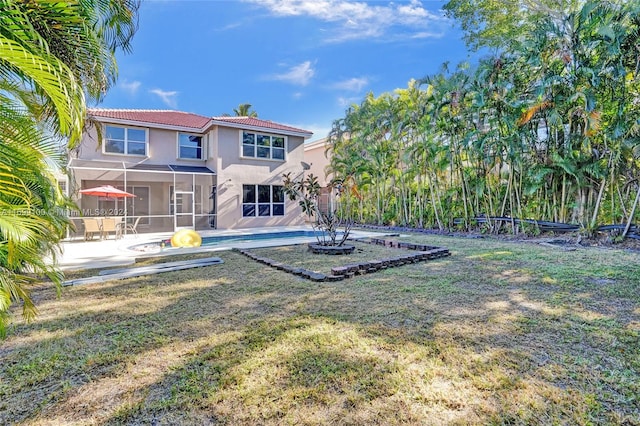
xmin=69 ymin=159 xmax=216 ymax=237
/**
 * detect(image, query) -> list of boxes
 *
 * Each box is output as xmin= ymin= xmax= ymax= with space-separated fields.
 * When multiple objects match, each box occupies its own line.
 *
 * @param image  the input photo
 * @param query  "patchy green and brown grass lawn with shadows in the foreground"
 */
xmin=0 ymin=235 xmax=640 ymax=425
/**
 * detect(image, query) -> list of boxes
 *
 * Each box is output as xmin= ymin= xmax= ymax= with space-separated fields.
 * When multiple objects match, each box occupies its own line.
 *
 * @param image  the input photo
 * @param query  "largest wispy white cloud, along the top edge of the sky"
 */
xmin=245 ymin=0 xmax=449 ymax=42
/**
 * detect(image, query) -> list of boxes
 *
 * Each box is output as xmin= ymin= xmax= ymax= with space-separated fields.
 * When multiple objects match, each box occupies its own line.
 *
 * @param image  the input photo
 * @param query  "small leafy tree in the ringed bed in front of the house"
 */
xmin=283 ymin=173 xmax=353 ymax=247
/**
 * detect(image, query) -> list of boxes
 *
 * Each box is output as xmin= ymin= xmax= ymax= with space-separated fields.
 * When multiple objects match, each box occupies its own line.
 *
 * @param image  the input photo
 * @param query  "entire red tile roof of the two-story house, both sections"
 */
xmin=87 ymin=108 xmax=312 ymax=137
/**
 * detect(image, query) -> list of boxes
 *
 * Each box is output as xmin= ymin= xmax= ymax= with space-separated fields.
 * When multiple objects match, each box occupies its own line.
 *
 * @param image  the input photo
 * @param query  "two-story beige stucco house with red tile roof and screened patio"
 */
xmin=69 ymin=109 xmax=312 ymax=236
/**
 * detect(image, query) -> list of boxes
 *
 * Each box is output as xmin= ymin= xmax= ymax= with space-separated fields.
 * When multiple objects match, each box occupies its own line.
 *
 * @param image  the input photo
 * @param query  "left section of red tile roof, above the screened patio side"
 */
xmin=87 ymin=108 xmax=211 ymax=130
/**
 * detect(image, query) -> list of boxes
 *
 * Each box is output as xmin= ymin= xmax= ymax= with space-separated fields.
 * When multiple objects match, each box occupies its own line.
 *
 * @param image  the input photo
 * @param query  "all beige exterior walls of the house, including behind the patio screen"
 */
xmin=74 ymin=118 xmax=304 ymax=232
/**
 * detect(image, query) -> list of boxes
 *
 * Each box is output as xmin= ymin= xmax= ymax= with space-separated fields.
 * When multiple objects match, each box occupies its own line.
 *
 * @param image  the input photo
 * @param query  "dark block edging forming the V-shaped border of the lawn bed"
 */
xmin=233 ymin=238 xmax=451 ymax=282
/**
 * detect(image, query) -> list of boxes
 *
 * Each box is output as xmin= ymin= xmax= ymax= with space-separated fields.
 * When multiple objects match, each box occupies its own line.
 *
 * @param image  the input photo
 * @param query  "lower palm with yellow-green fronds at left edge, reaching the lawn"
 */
xmin=0 ymin=88 xmax=69 ymax=336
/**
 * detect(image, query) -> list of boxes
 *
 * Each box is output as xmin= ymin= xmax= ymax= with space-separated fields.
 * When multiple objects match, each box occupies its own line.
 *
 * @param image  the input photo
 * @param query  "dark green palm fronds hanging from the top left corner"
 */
xmin=0 ymin=0 xmax=139 ymax=100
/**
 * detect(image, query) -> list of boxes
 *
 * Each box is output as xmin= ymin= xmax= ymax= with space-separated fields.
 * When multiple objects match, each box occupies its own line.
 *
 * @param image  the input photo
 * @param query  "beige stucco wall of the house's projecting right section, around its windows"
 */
xmin=212 ymin=127 xmax=304 ymax=229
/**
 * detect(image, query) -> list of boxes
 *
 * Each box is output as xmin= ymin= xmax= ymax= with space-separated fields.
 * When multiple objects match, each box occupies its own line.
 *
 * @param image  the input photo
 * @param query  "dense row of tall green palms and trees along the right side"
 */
xmin=330 ymin=0 xmax=640 ymax=234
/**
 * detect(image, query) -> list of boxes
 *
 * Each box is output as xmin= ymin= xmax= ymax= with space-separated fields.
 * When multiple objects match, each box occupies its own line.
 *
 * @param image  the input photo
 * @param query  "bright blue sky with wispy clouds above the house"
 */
xmin=94 ymin=0 xmax=469 ymax=140
